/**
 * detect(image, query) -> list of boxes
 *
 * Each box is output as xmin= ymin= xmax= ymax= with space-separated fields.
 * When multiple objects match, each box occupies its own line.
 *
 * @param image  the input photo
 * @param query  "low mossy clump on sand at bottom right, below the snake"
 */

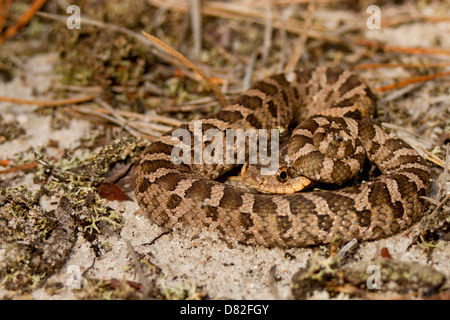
xmin=292 ymin=257 xmax=446 ymax=299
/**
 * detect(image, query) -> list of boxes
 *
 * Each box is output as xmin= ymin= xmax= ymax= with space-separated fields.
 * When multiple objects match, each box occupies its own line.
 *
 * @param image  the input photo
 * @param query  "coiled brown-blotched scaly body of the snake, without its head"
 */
xmin=133 ymin=67 xmax=430 ymax=247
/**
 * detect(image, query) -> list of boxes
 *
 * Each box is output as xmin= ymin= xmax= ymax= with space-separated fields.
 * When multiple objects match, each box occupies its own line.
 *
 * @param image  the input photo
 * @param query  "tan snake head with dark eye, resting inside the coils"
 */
xmin=241 ymin=163 xmax=312 ymax=194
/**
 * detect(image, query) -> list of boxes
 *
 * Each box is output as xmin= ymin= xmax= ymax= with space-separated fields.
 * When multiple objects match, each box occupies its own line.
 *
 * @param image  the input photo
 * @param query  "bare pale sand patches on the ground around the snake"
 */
xmin=0 ymin=6 xmax=450 ymax=299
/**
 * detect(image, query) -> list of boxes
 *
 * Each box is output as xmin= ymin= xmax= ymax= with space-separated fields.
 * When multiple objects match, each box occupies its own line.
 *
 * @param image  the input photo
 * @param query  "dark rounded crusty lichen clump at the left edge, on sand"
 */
xmin=0 ymin=186 xmax=75 ymax=292
